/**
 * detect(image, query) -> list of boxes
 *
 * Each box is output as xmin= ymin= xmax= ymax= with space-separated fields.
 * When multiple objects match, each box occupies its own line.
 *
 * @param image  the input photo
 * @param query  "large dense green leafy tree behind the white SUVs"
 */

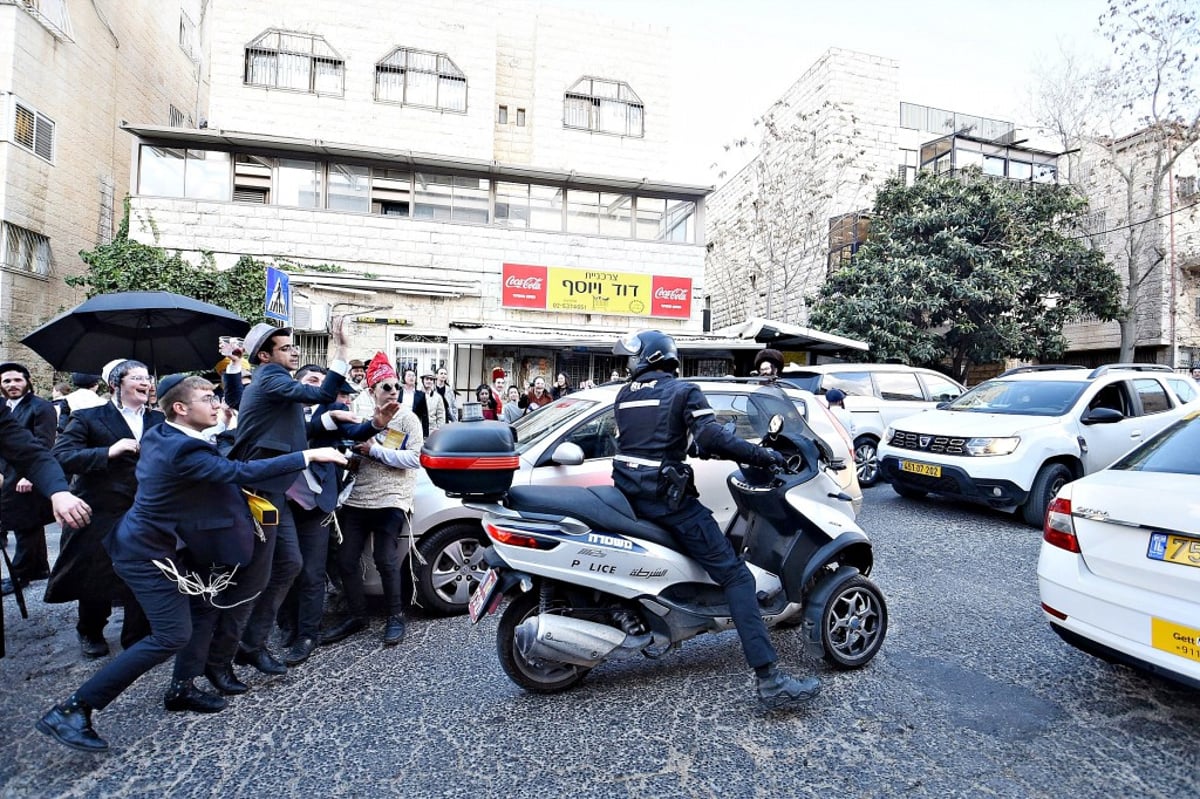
xmin=811 ymin=168 xmax=1122 ymax=380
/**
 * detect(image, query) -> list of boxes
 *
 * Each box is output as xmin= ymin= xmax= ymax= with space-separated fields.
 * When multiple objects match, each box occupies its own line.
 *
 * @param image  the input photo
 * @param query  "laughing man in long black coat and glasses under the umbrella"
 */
xmin=46 ymin=360 xmax=163 ymax=657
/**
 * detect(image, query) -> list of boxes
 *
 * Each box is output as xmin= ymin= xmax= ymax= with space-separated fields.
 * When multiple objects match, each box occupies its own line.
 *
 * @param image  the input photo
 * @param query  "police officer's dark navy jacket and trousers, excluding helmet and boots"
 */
xmin=613 ymin=372 xmax=778 ymax=668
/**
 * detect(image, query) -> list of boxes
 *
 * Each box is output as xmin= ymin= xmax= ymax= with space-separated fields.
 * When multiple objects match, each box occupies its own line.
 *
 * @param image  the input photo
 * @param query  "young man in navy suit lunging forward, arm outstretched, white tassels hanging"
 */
xmin=37 ymin=374 xmax=346 ymax=752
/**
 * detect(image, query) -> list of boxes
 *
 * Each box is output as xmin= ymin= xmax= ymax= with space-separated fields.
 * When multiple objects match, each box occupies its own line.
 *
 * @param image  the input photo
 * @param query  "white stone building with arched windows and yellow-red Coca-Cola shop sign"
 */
xmin=126 ymin=0 xmax=715 ymax=389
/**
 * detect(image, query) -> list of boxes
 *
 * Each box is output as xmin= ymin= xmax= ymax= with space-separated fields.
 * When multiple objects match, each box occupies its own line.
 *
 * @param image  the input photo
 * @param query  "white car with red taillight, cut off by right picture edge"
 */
xmin=1038 ymin=411 xmax=1200 ymax=687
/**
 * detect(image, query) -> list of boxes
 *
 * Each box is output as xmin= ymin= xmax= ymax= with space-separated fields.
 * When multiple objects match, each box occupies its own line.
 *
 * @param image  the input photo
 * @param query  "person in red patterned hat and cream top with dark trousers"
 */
xmin=322 ymin=353 xmax=425 ymax=647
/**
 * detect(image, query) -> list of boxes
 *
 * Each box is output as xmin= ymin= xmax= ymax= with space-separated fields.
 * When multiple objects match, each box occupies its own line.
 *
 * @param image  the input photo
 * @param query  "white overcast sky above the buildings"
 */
xmin=546 ymin=0 xmax=1109 ymax=185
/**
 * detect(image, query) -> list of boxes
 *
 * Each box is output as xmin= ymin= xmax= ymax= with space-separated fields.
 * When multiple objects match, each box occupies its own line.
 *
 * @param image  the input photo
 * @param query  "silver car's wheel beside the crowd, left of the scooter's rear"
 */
xmin=416 ymin=522 xmax=487 ymax=615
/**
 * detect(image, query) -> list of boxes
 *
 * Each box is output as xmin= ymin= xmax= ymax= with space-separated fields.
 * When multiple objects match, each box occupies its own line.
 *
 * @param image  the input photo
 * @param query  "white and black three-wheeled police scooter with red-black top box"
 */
xmin=422 ymin=388 xmax=888 ymax=693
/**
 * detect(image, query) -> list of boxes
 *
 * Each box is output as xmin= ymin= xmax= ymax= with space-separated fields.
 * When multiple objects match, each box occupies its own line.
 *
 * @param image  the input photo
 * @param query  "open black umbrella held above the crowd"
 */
xmin=20 ymin=292 xmax=250 ymax=374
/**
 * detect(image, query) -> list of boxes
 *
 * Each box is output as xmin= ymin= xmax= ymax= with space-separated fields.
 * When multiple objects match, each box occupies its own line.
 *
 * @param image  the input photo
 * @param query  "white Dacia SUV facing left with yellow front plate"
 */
xmin=880 ymin=364 xmax=1194 ymax=527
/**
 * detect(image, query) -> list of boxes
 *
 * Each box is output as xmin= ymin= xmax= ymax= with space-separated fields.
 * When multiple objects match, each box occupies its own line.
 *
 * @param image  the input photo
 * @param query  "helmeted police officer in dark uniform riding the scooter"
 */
xmin=612 ymin=330 xmax=821 ymax=708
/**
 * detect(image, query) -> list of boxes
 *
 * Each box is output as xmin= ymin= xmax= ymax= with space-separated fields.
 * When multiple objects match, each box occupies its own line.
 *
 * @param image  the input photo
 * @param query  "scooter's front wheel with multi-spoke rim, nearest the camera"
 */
xmin=821 ymin=575 xmax=888 ymax=669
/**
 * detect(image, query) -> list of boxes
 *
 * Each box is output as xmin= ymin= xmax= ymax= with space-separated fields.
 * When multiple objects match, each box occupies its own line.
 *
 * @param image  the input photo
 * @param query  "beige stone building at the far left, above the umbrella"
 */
xmin=0 ymin=0 xmax=208 ymax=364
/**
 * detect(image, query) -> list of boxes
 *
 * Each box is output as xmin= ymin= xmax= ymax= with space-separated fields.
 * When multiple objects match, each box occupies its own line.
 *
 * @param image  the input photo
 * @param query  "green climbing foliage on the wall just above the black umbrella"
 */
xmin=66 ymin=200 xmax=266 ymax=324
